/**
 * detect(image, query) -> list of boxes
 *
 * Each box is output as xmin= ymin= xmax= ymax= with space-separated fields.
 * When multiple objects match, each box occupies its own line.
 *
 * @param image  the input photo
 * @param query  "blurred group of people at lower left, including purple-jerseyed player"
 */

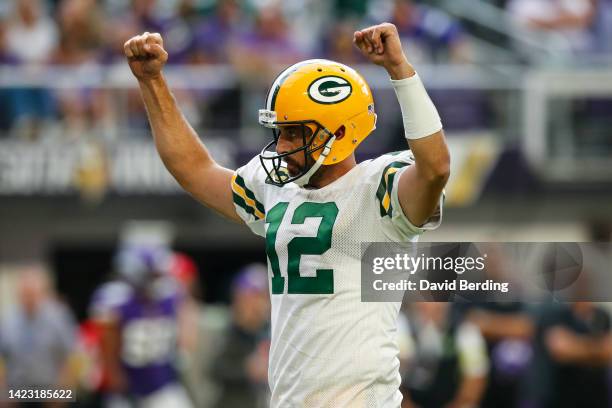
xmin=0 ymin=246 xmax=270 ymax=408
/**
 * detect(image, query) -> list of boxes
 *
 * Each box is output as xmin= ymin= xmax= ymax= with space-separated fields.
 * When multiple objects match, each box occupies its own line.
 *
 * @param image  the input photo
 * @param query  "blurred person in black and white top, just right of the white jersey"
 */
xmin=399 ymin=302 xmax=489 ymax=408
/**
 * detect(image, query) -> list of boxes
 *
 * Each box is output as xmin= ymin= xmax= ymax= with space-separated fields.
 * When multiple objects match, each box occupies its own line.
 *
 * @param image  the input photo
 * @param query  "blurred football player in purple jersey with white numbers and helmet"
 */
xmin=92 ymin=247 xmax=191 ymax=408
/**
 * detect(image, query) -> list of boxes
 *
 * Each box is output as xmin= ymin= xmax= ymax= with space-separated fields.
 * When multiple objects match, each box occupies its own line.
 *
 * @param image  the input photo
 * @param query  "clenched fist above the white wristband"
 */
xmin=353 ymin=23 xmax=414 ymax=79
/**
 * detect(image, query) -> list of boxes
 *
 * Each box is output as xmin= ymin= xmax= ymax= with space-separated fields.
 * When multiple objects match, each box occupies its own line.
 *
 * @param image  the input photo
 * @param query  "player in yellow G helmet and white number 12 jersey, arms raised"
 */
xmin=124 ymin=23 xmax=450 ymax=408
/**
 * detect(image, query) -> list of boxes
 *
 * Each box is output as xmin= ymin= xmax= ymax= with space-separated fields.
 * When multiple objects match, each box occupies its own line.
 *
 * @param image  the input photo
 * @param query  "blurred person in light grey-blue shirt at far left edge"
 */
xmin=0 ymin=266 xmax=76 ymax=406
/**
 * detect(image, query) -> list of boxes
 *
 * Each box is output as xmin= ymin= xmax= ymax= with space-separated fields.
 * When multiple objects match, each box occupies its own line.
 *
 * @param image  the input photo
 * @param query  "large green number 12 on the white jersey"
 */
xmin=266 ymin=202 xmax=338 ymax=294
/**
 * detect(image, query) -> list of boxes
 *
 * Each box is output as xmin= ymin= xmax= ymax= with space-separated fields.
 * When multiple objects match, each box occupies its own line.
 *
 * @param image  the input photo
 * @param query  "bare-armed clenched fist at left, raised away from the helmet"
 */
xmin=123 ymin=32 xmax=168 ymax=81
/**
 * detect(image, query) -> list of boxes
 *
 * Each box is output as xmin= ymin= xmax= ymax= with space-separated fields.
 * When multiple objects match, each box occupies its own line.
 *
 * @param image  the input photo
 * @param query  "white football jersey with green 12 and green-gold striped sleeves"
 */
xmin=232 ymin=151 xmax=442 ymax=408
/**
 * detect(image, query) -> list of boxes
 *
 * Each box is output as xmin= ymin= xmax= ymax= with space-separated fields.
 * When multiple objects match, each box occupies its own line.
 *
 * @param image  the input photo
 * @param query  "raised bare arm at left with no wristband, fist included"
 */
xmin=124 ymin=33 xmax=242 ymax=222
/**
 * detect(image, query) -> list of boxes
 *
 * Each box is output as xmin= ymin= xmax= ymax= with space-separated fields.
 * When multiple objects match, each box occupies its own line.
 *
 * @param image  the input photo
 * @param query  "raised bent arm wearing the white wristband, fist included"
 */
xmin=353 ymin=23 xmax=450 ymax=226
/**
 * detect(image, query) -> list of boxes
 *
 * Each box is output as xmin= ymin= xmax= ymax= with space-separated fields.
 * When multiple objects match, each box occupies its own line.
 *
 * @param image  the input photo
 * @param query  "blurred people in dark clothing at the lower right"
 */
xmin=400 ymin=302 xmax=612 ymax=408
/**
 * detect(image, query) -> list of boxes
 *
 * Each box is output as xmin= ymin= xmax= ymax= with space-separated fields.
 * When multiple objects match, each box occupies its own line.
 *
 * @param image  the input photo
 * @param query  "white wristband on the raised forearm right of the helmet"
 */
xmin=391 ymin=73 xmax=442 ymax=140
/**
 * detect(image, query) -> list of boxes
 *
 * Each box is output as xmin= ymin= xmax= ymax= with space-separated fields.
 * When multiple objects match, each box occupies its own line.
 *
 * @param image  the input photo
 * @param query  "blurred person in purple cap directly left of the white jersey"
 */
xmin=212 ymin=264 xmax=270 ymax=408
